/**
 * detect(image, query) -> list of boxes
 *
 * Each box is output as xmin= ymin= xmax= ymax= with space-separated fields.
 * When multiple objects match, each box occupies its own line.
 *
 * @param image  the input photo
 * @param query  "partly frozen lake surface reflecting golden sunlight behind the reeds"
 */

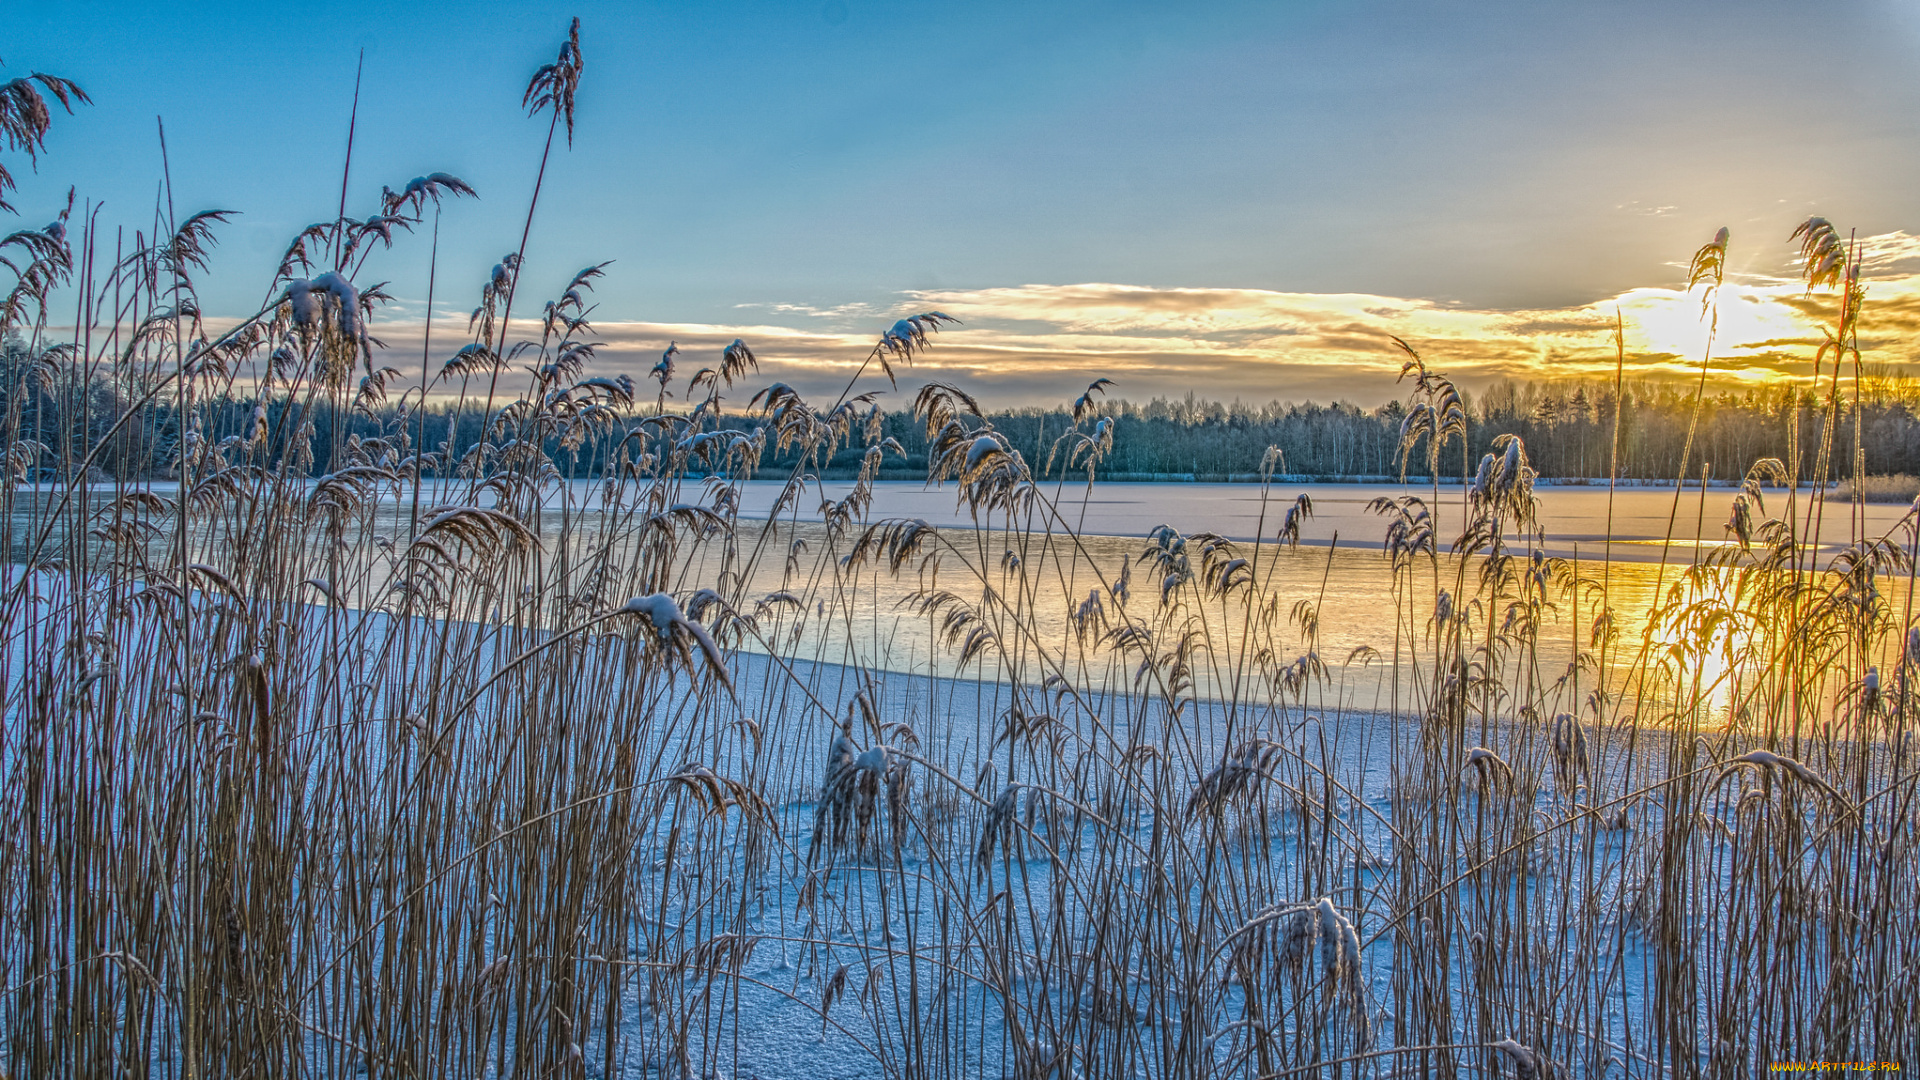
xmin=683 ymin=482 xmax=1912 ymax=723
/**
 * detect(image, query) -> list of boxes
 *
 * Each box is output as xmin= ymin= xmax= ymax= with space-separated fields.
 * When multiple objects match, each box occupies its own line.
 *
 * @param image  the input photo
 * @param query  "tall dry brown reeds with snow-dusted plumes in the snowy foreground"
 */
xmin=0 ymin=21 xmax=1920 ymax=1080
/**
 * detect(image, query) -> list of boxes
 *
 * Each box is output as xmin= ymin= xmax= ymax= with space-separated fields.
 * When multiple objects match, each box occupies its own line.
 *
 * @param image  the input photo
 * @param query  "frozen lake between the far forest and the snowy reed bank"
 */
xmin=13 ymin=480 xmax=1910 ymax=715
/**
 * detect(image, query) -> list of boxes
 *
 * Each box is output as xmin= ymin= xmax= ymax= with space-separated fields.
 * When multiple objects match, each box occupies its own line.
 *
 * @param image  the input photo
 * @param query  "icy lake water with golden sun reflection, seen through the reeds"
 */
xmin=13 ymin=480 xmax=1912 ymax=719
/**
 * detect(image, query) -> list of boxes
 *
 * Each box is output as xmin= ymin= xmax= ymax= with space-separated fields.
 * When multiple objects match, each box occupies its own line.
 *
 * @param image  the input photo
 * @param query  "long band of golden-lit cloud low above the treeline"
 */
xmin=278 ymin=244 xmax=1920 ymax=405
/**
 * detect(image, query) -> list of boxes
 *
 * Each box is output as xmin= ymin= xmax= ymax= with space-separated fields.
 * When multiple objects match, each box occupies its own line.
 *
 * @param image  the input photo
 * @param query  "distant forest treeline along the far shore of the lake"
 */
xmin=11 ymin=342 xmax=1920 ymax=480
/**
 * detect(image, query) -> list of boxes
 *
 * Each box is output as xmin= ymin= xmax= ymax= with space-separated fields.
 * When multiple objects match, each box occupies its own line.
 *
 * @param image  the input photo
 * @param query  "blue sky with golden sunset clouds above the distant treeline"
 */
xmin=11 ymin=0 xmax=1920 ymax=405
